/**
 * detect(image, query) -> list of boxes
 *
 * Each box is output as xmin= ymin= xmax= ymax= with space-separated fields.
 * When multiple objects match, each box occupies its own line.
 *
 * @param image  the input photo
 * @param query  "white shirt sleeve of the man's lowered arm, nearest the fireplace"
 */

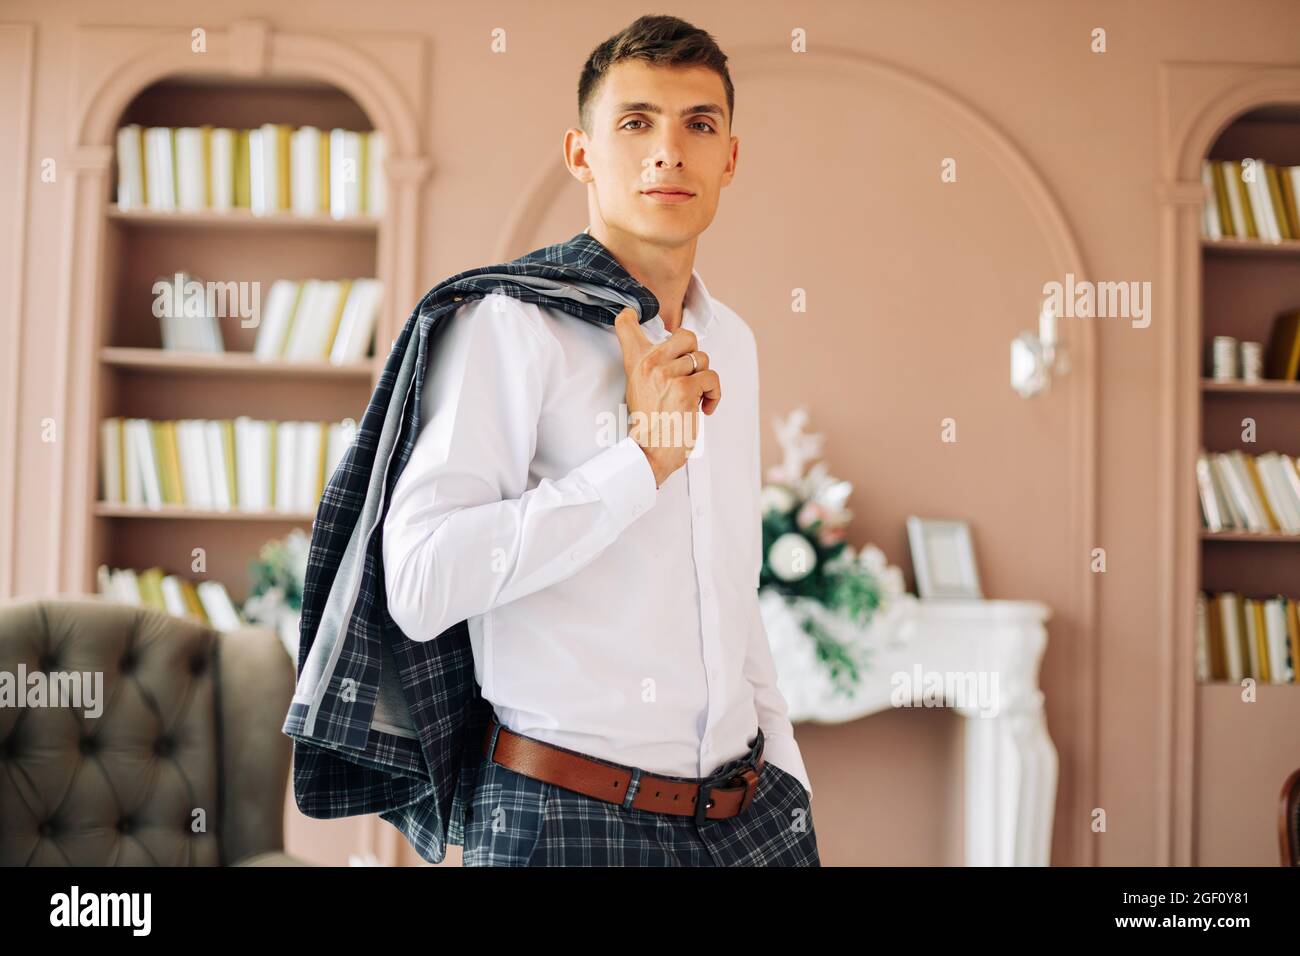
xmin=745 ymin=335 xmax=813 ymax=797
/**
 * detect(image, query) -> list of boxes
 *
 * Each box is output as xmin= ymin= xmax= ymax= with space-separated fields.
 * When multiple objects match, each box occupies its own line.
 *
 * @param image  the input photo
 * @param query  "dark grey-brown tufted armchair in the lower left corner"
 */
xmin=0 ymin=596 xmax=303 ymax=866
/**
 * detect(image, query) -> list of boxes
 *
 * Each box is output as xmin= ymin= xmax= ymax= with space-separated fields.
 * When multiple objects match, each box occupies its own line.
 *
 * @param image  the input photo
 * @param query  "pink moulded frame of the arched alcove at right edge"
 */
xmin=1156 ymin=62 xmax=1300 ymax=866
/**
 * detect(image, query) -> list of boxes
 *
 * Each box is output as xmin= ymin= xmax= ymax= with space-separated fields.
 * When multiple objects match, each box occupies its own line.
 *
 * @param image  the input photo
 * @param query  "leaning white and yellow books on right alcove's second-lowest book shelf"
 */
xmin=1196 ymin=449 xmax=1300 ymax=535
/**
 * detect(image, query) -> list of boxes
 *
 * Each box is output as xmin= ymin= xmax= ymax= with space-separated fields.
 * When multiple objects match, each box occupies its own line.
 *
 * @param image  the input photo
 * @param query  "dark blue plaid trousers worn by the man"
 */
xmin=463 ymin=734 xmax=822 ymax=866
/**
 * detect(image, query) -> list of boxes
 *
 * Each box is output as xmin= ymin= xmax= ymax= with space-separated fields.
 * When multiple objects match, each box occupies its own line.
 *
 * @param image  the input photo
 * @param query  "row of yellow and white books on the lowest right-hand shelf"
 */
xmin=1195 ymin=591 xmax=1300 ymax=684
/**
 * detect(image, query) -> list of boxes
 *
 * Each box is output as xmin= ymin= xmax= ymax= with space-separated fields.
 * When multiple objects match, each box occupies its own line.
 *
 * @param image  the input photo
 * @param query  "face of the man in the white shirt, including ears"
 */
xmin=566 ymin=60 xmax=738 ymax=246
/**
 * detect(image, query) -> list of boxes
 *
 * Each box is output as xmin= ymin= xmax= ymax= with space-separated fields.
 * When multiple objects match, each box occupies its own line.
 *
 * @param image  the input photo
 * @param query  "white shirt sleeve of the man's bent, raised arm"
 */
xmin=382 ymin=293 xmax=658 ymax=641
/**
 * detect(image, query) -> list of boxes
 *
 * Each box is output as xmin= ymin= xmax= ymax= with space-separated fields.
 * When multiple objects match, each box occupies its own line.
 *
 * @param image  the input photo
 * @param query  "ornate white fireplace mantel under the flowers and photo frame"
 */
xmin=759 ymin=591 xmax=1057 ymax=866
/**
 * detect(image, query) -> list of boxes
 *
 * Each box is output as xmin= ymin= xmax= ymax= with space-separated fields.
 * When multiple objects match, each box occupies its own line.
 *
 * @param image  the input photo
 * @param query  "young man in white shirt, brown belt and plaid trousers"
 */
xmin=384 ymin=16 xmax=820 ymax=866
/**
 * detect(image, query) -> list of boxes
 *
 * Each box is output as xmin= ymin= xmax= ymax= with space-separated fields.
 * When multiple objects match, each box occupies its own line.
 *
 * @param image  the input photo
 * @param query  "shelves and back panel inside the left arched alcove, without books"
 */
xmin=94 ymin=74 xmax=394 ymax=606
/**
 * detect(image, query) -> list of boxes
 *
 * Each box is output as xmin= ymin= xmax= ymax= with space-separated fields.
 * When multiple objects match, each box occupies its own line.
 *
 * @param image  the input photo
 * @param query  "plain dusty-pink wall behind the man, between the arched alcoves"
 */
xmin=0 ymin=0 xmax=1300 ymax=865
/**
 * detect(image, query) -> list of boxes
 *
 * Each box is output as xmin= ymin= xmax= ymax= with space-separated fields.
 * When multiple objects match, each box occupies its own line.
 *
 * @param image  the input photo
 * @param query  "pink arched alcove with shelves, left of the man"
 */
xmin=46 ymin=21 xmax=429 ymax=861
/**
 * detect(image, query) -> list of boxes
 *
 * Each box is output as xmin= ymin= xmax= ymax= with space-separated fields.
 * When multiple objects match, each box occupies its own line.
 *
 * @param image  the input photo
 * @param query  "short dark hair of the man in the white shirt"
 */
xmin=577 ymin=14 xmax=736 ymax=133
